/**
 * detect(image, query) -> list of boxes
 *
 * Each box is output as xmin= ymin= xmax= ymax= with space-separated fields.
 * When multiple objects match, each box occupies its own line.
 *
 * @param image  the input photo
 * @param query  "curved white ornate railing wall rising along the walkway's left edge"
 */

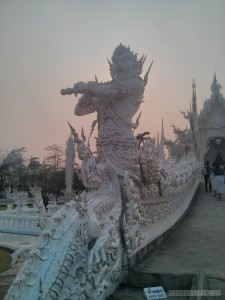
xmin=124 ymin=174 xmax=200 ymax=268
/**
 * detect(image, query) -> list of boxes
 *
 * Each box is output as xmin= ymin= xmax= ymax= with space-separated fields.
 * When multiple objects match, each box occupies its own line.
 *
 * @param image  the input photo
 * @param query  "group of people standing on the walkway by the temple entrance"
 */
xmin=204 ymin=161 xmax=225 ymax=200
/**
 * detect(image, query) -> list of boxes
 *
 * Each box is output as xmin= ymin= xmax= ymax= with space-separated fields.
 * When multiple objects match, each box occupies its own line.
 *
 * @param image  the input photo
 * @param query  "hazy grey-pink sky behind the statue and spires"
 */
xmin=0 ymin=0 xmax=225 ymax=158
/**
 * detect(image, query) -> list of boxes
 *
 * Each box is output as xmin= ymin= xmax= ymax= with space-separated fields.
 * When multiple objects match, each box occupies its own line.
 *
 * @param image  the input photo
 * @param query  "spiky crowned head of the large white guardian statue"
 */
xmin=108 ymin=44 xmax=146 ymax=80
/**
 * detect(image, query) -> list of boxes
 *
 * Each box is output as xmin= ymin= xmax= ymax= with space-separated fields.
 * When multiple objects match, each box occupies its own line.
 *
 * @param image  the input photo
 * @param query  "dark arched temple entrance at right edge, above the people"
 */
xmin=204 ymin=137 xmax=225 ymax=165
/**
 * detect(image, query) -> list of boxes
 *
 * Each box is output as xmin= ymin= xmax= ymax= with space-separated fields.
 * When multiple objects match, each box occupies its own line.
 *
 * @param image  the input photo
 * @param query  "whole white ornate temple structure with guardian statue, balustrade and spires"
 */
xmin=1 ymin=44 xmax=212 ymax=300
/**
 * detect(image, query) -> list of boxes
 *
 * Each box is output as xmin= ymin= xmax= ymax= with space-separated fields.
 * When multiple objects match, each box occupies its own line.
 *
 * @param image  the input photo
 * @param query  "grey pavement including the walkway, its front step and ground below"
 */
xmin=109 ymin=187 xmax=225 ymax=300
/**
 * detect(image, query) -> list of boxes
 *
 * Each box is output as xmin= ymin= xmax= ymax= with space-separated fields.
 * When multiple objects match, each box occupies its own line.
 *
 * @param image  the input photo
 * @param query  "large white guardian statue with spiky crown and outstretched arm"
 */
xmin=61 ymin=44 xmax=152 ymax=177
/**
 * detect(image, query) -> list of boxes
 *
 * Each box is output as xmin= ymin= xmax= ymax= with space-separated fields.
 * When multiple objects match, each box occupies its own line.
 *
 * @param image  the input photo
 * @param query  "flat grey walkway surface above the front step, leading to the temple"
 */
xmin=134 ymin=186 xmax=225 ymax=280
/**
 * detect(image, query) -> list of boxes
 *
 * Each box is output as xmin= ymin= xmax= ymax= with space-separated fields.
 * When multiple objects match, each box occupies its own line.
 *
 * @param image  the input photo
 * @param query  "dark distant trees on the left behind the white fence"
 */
xmin=0 ymin=144 xmax=84 ymax=197
